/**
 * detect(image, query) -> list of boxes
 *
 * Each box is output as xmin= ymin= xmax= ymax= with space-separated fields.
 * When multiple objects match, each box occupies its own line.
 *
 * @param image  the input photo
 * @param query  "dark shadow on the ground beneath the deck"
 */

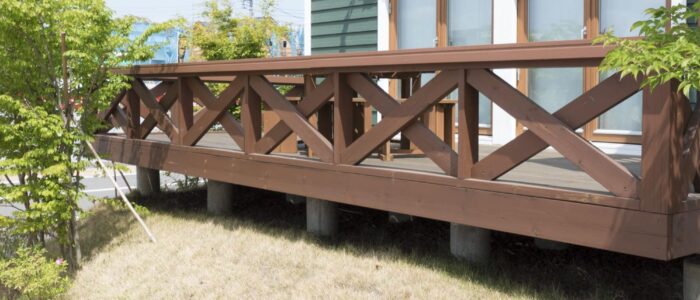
xmin=131 ymin=187 xmax=682 ymax=299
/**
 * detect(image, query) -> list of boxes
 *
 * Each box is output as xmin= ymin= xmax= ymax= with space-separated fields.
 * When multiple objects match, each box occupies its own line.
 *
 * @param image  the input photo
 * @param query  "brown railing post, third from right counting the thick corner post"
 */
xmin=333 ymin=73 xmax=354 ymax=164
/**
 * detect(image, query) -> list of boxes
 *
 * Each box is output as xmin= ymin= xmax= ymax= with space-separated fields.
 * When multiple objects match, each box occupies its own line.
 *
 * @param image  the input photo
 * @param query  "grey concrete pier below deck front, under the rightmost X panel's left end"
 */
xmin=450 ymin=223 xmax=491 ymax=264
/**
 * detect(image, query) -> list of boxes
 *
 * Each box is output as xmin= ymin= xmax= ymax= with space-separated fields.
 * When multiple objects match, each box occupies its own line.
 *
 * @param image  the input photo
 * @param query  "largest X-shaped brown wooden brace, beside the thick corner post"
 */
xmin=467 ymin=70 xmax=639 ymax=198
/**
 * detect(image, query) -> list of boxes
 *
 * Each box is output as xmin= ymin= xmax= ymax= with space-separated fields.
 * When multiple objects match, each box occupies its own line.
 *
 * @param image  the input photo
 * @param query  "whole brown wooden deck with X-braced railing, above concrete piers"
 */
xmin=94 ymin=41 xmax=700 ymax=260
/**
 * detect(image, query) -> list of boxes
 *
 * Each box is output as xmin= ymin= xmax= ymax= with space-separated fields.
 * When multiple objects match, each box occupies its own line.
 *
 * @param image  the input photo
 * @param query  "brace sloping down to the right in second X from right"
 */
xmin=348 ymin=73 xmax=457 ymax=176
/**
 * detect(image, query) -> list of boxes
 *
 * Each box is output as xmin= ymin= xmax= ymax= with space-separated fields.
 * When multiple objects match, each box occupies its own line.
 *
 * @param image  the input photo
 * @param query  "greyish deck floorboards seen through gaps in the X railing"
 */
xmin=147 ymin=132 xmax=641 ymax=195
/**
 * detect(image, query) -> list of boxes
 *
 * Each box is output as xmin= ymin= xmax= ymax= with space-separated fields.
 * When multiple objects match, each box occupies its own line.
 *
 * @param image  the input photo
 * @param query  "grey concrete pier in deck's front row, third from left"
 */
xmin=306 ymin=198 xmax=338 ymax=237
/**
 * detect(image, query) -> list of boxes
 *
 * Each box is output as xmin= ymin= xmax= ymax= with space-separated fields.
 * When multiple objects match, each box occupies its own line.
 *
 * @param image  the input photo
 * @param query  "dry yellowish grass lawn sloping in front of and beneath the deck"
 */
xmin=66 ymin=192 xmax=679 ymax=299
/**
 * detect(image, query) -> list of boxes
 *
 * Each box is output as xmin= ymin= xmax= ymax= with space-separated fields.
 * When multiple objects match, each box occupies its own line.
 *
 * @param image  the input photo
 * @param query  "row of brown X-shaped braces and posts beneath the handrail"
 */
xmin=101 ymin=69 xmax=644 ymax=198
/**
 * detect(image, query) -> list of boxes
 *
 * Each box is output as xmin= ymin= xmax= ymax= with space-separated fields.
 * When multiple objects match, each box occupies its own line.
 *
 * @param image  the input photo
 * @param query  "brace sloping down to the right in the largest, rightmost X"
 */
xmin=467 ymin=70 xmax=639 ymax=198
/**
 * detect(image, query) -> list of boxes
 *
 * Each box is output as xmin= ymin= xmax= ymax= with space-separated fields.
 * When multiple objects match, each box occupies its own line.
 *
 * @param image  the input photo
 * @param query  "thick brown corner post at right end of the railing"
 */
xmin=639 ymin=83 xmax=690 ymax=214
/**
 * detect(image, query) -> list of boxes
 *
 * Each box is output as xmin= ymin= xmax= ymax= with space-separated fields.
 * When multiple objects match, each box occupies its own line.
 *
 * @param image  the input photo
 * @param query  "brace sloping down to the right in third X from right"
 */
xmin=246 ymin=76 xmax=333 ymax=162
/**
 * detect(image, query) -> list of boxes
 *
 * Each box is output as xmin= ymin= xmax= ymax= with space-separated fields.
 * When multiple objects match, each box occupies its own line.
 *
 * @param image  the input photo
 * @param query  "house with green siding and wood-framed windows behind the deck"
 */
xmin=305 ymin=0 xmax=695 ymax=154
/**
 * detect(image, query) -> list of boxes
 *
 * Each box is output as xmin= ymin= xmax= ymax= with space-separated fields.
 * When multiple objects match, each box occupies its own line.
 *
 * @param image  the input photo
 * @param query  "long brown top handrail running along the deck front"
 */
xmin=113 ymin=40 xmax=612 ymax=77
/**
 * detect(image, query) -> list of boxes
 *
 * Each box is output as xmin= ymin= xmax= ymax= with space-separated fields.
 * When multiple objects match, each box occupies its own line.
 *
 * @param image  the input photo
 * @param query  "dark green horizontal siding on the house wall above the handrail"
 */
xmin=311 ymin=0 xmax=377 ymax=54
